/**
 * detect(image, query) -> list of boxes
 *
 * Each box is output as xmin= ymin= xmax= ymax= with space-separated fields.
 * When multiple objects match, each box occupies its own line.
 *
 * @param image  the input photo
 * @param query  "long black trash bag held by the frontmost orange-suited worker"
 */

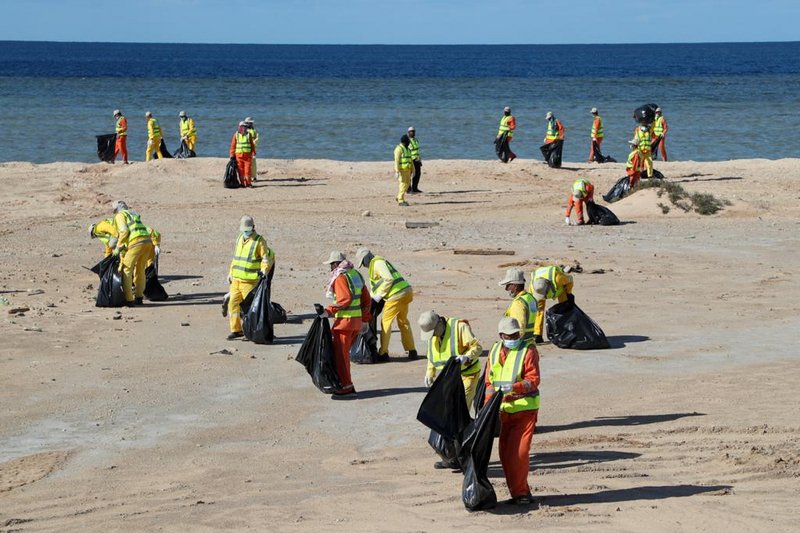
xmin=461 ymin=391 xmax=503 ymax=511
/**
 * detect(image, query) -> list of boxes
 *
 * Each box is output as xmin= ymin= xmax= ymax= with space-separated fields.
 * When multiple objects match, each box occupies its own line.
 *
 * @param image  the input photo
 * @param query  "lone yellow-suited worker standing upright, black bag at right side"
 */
xmin=228 ymin=215 xmax=275 ymax=341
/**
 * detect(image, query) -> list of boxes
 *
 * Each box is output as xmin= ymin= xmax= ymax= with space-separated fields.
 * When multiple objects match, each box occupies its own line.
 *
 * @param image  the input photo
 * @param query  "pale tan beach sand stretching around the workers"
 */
xmin=0 ymin=158 xmax=800 ymax=532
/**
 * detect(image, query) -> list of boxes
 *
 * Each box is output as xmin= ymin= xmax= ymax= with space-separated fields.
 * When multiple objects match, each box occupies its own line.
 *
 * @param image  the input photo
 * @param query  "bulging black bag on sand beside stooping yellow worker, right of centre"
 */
xmin=545 ymin=294 xmax=609 ymax=350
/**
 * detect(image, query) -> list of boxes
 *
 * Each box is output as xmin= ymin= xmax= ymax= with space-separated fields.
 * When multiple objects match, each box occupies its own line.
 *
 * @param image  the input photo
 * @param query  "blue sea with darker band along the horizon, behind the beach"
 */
xmin=0 ymin=41 xmax=800 ymax=163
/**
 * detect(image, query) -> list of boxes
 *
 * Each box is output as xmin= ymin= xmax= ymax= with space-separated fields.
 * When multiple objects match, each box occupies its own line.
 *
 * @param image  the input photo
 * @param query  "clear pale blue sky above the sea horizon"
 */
xmin=0 ymin=0 xmax=800 ymax=44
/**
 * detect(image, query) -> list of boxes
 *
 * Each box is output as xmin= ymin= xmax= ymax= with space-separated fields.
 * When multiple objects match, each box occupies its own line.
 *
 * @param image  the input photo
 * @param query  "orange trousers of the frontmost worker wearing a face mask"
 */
xmin=498 ymin=409 xmax=539 ymax=498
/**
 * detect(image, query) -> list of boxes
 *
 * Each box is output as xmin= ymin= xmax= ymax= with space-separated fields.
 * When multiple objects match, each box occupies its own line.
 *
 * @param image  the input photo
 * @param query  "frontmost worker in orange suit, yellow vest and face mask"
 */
xmin=485 ymin=317 xmax=541 ymax=505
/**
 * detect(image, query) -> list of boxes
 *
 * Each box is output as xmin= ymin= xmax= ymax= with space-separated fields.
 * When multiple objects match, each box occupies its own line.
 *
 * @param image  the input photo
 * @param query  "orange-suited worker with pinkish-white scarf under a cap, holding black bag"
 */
xmin=314 ymin=251 xmax=372 ymax=396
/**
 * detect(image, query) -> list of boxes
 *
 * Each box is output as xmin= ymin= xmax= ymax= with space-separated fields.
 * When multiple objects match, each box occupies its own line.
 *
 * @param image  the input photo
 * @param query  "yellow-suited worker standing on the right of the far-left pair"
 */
xmin=111 ymin=200 xmax=153 ymax=306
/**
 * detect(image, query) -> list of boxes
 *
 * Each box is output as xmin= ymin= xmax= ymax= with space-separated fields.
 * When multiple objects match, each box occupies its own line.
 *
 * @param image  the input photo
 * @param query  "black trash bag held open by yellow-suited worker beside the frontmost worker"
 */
xmin=417 ymin=357 xmax=472 ymax=440
